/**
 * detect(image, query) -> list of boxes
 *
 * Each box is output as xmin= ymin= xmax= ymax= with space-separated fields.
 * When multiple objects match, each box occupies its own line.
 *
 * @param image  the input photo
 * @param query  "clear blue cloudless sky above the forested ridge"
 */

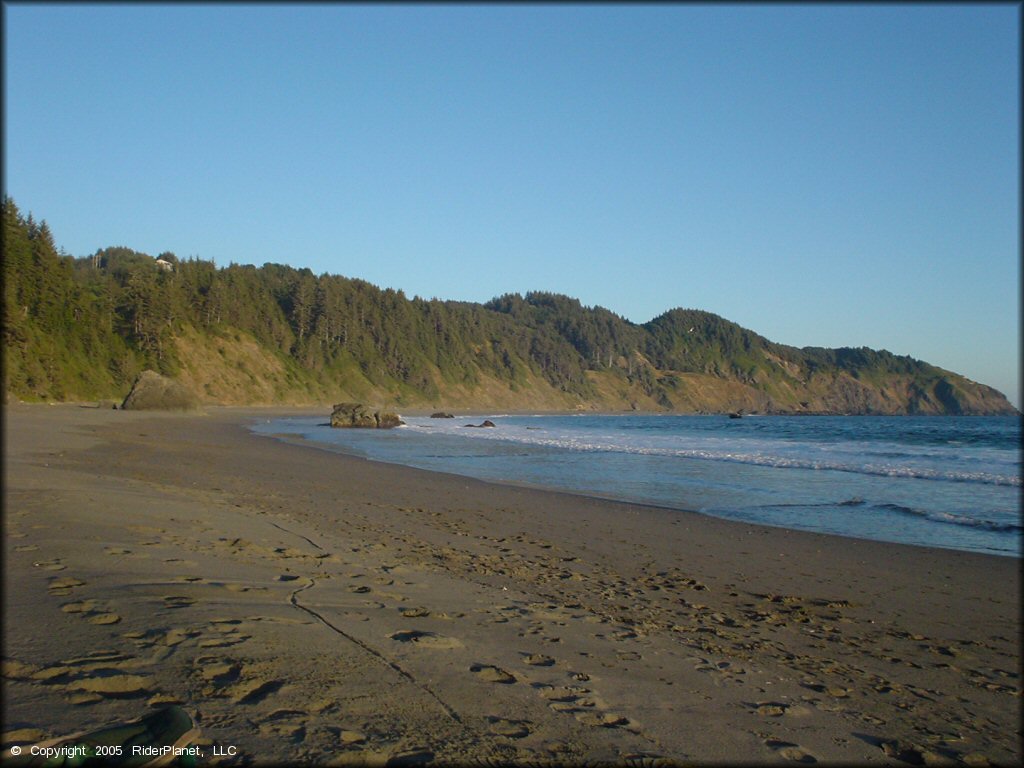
xmin=4 ymin=3 xmax=1021 ymax=406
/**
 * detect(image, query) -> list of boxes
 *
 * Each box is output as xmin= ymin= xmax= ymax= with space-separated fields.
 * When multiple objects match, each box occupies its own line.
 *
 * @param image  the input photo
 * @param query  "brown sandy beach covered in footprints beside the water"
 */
xmin=3 ymin=403 xmax=1022 ymax=765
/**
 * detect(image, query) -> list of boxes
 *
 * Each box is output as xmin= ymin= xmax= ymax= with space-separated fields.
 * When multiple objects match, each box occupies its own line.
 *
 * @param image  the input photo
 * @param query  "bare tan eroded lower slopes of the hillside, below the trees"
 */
xmin=32 ymin=329 xmax=1019 ymax=416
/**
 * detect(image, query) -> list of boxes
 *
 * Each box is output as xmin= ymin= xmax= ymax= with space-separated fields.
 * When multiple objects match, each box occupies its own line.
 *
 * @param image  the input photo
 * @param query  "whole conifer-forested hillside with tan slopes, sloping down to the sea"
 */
xmin=3 ymin=198 xmax=1015 ymax=414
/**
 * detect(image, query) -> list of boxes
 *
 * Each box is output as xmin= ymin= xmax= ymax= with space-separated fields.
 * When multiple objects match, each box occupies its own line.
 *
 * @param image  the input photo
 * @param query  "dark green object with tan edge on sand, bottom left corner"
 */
xmin=0 ymin=707 xmax=199 ymax=768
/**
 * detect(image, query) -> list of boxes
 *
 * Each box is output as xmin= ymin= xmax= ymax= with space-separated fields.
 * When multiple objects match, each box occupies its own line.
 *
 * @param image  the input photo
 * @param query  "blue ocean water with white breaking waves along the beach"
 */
xmin=253 ymin=414 xmax=1022 ymax=557
